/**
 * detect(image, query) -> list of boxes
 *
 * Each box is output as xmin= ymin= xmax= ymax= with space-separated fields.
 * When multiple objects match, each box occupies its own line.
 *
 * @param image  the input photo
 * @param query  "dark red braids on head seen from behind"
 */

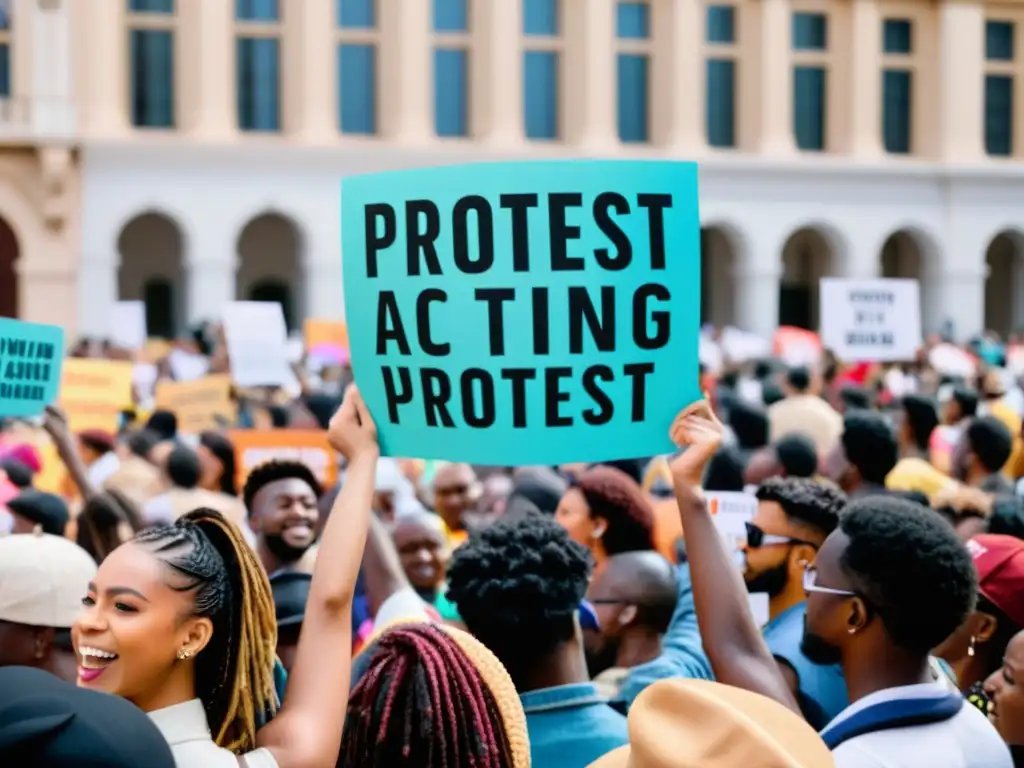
xmin=338 ymin=624 xmax=512 ymax=768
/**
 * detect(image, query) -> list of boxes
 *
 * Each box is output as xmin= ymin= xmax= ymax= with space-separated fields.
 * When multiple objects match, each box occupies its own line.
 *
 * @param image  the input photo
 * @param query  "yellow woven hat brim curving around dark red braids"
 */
xmin=352 ymin=616 xmax=530 ymax=768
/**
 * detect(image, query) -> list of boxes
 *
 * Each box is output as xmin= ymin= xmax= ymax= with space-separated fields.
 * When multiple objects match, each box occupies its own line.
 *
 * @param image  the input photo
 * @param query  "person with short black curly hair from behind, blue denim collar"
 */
xmin=447 ymin=512 xmax=629 ymax=766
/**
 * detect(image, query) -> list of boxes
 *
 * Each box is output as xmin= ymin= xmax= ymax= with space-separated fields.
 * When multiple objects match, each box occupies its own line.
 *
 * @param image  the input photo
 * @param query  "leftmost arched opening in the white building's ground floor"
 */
xmin=118 ymin=212 xmax=184 ymax=339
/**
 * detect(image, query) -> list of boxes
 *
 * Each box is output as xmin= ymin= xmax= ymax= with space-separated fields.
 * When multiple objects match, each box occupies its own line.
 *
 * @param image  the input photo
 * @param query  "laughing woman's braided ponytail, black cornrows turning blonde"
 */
xmin=134 ymin=509 xmax=279 ymax=754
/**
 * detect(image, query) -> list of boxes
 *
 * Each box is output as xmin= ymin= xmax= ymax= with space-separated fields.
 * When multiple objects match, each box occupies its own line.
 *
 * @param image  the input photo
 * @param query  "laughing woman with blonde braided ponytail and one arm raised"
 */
xmin=73 ymin=387 xmax=379 ymax=768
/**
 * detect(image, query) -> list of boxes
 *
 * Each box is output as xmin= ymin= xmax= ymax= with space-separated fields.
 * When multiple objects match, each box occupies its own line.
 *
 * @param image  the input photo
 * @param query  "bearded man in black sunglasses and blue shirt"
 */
xmin=743 ymin=477 xmax=848 ymax=728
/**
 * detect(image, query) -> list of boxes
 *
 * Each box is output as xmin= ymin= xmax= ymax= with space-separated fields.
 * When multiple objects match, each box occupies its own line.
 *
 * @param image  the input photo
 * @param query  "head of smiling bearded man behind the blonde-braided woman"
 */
xmin=242 ymin=461 xmax=323 ymax=575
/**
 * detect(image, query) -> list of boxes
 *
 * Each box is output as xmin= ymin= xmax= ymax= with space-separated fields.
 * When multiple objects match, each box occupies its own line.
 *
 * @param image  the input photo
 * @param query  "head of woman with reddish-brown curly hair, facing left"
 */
xmin=555 ymin=465 xmax=654 ymax=568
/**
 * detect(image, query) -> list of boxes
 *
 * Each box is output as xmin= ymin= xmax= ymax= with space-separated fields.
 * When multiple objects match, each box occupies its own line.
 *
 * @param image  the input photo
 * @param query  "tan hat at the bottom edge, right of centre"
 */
xmin=590 ymin=680 xmax=835 ymax=768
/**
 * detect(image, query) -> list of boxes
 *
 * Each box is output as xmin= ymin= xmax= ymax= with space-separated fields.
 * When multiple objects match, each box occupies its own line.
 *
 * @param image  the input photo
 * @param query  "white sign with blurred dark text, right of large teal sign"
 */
xmin=820 ymin=278 xmax=921 ymax=362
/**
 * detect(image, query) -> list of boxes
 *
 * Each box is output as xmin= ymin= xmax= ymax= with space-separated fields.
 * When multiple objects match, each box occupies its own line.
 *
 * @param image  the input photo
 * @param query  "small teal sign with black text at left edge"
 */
xmin=0 ymin=317 xmax=63 ymax=416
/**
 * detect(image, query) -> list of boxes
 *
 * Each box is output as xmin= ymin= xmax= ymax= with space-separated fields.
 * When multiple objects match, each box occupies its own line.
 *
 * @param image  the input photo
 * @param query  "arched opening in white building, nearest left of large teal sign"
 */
xmin=234 ymin=213 xmax=302 ymax=330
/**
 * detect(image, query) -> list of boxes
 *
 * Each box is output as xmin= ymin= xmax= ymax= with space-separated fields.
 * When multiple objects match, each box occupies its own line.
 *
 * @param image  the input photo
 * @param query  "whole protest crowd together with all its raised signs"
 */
xmin=0 ymin=157 xmax=1024 ymax=768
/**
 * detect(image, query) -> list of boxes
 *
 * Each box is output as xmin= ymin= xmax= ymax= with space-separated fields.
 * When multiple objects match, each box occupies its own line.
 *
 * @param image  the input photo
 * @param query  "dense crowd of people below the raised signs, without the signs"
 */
xmin=0 ymin=327 xmax=1024 ymax=768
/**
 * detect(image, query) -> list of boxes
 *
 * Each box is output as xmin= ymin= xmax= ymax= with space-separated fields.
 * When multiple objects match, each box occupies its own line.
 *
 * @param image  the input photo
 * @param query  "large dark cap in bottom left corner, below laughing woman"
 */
xmin=0 ymin=667 xmax=174 ymax=768
